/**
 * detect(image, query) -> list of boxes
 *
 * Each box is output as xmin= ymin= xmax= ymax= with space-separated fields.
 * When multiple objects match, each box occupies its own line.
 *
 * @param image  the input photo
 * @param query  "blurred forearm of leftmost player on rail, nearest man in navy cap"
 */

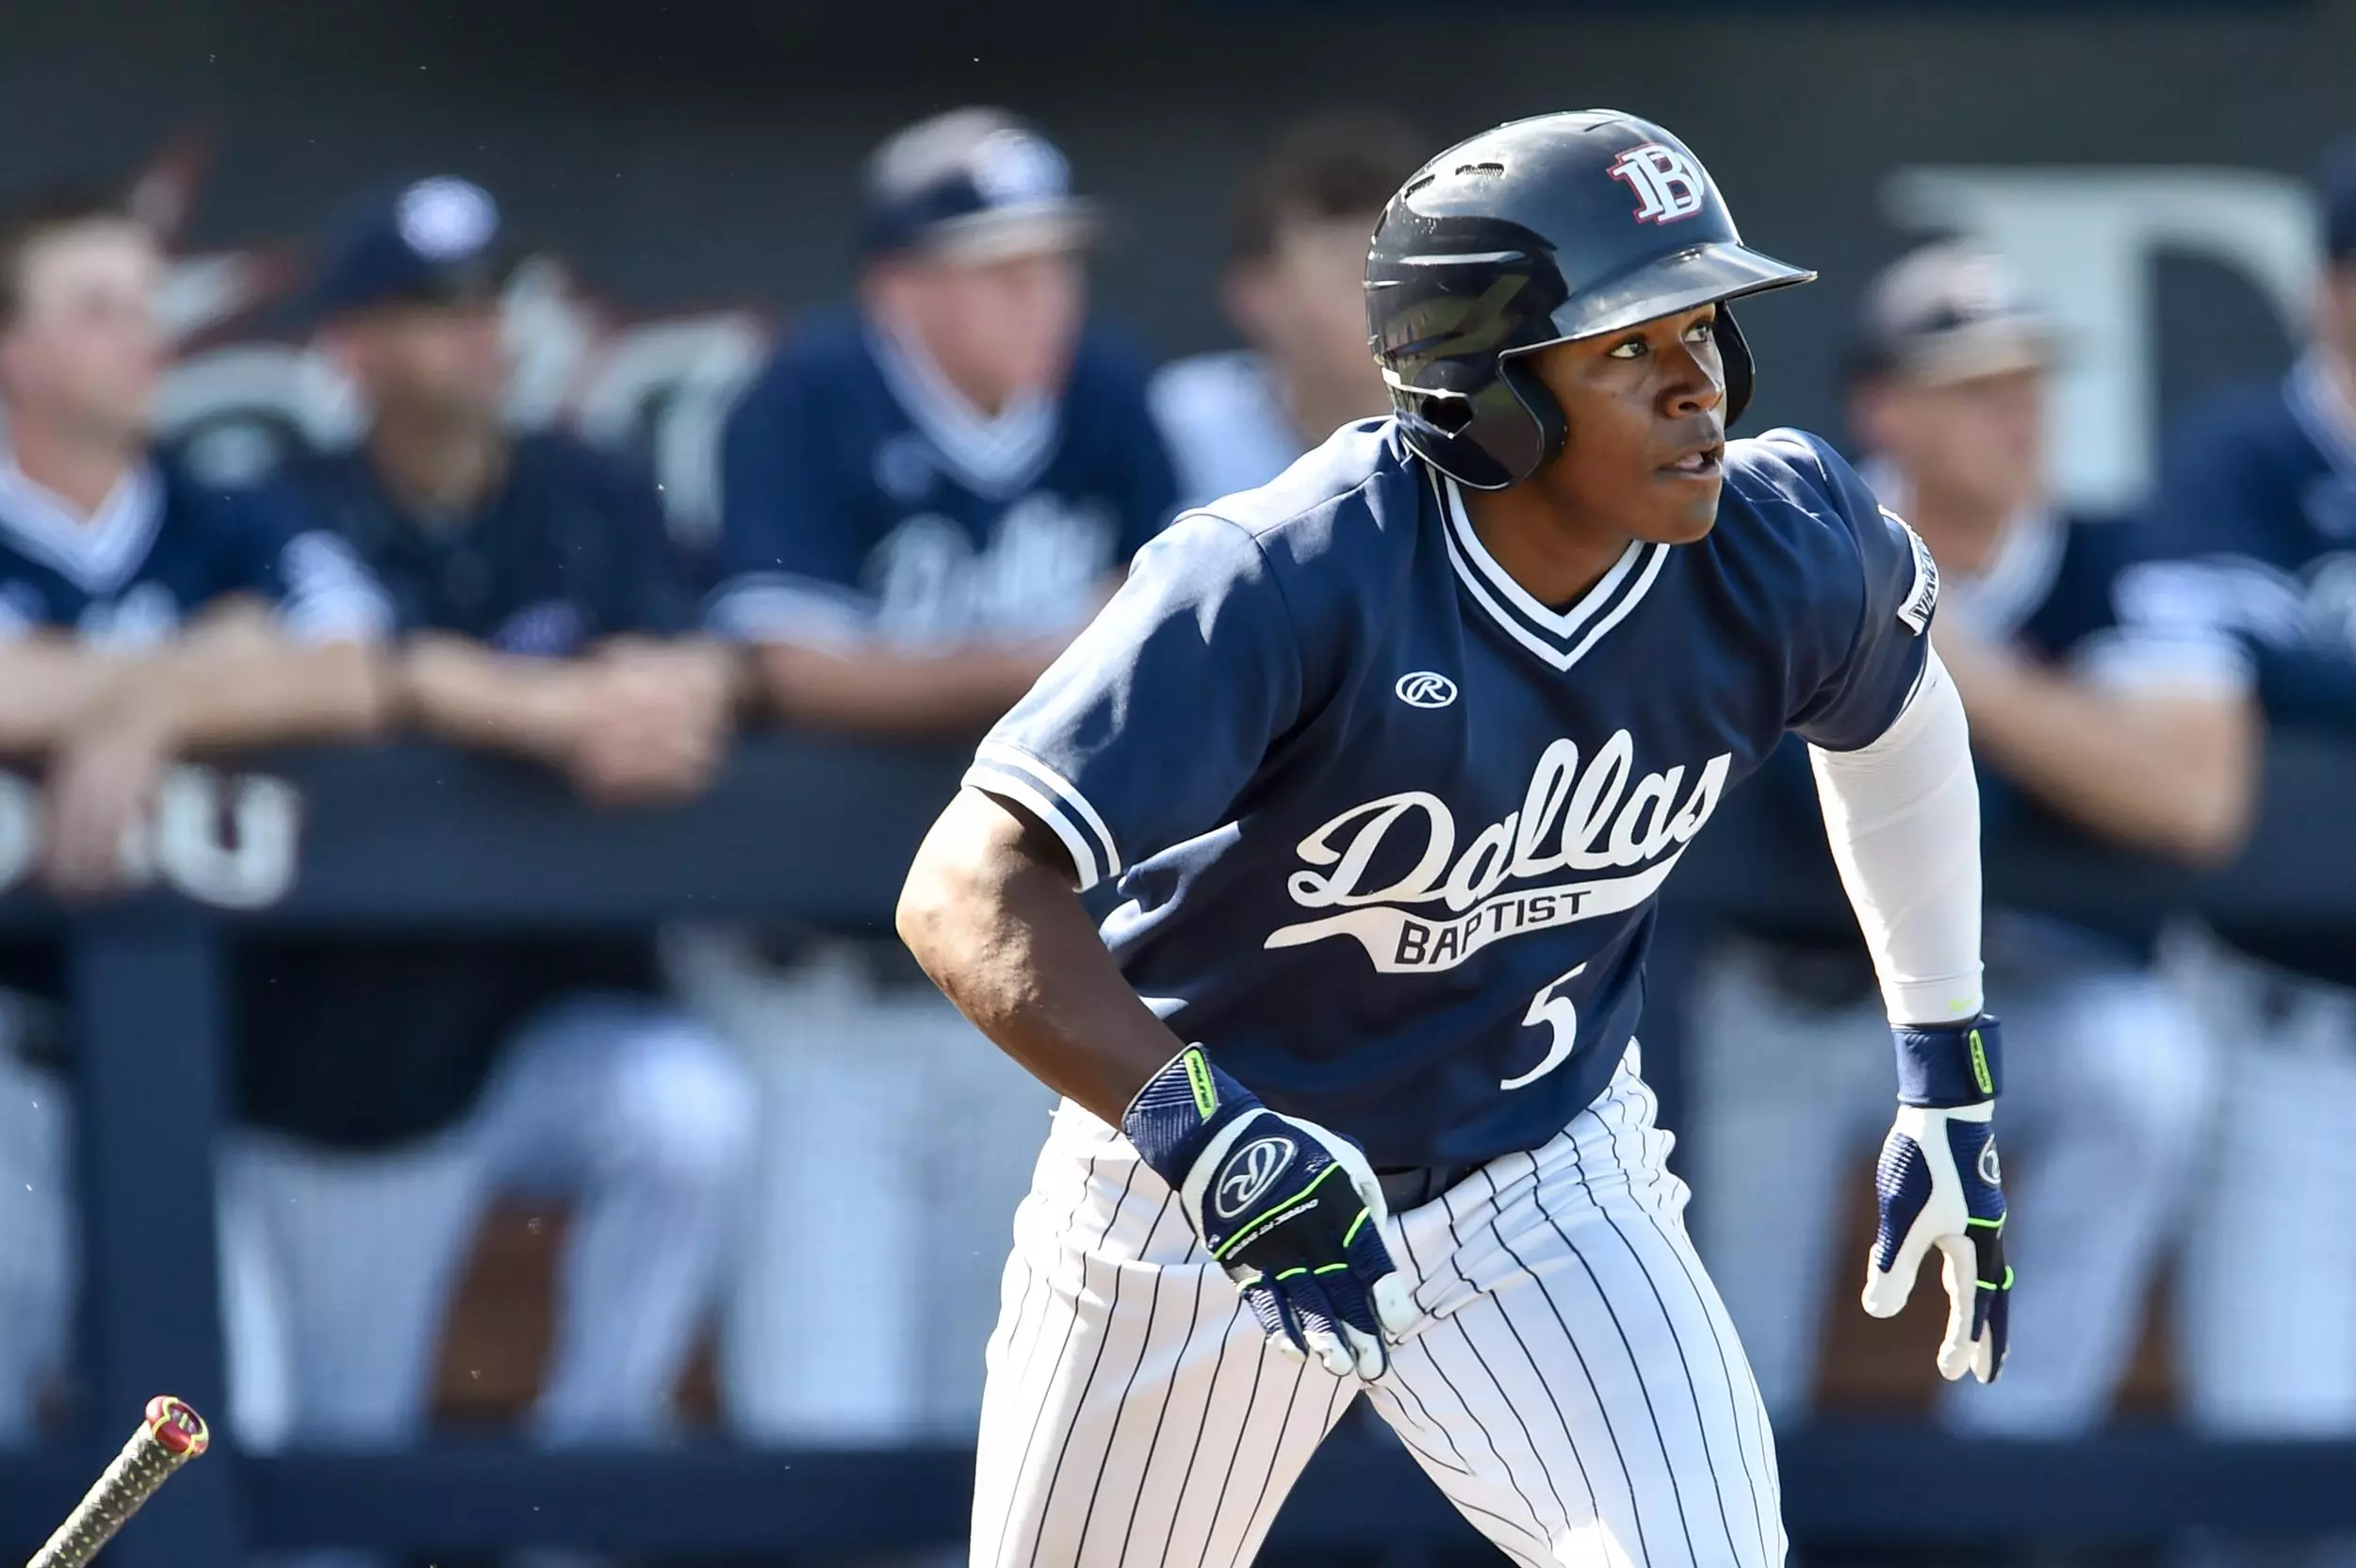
xmin=80 ymin=638 xmax=391 ymax=751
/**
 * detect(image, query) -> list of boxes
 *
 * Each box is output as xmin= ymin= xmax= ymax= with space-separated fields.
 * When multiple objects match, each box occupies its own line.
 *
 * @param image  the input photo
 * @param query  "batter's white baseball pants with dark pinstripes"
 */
xmin=973 ymin=1048 xmax=1784 ymax=1568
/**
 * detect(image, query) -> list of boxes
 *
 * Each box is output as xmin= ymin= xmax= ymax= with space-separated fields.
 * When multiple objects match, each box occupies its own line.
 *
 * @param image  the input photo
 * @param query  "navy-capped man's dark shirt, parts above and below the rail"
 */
xmin=238 ymin=431 xmax=697 ymax=1149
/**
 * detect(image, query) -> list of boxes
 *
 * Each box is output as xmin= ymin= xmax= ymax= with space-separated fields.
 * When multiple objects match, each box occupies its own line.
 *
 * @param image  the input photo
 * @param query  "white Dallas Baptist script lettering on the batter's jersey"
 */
xmin=1263 ymin=730 xmax=1734 ymax=974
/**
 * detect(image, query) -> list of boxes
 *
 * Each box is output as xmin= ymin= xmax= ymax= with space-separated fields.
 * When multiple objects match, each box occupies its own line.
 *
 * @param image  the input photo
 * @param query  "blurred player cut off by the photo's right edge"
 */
xmin=2125 ymin=141 xmax=2356 ymax=1450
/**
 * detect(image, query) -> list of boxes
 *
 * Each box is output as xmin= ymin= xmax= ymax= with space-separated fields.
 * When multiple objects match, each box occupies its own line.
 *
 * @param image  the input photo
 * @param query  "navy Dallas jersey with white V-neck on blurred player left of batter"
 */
xmin=714 ymin=313 xmax=1178 ymax=647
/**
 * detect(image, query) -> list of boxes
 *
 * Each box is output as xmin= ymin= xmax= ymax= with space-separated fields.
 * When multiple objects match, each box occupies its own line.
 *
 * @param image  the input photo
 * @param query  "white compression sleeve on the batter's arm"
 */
xmin=1808 ymin=652 xmax=1982 ymax=1024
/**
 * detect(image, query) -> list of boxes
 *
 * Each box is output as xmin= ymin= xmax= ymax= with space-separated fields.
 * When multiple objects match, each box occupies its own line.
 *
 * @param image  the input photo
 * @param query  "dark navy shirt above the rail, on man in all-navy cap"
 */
xmin=286 ymin=431 xmax=697 ymax=657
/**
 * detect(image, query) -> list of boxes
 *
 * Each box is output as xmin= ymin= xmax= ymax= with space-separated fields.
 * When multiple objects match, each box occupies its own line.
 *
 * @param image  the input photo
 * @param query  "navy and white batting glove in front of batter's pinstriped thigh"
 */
xmin=1121 ymin=1045 xmax=1416 ymax=1382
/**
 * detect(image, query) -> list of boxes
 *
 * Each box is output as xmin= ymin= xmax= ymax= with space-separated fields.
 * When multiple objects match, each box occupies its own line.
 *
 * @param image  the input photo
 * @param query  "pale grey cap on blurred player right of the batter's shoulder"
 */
xmin=1852 ymin=240 xmax=2057 ymax=384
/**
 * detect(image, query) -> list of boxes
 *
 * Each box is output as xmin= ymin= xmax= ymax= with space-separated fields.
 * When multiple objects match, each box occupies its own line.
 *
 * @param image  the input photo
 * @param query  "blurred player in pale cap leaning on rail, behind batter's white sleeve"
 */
xmin=1692 ymin=242 xmax=2257 ymax=1439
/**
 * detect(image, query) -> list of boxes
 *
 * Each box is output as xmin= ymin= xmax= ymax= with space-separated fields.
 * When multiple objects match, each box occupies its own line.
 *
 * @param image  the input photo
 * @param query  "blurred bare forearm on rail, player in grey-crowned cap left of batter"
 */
xmin=757 ymin=643 xmax=1049 ymax=737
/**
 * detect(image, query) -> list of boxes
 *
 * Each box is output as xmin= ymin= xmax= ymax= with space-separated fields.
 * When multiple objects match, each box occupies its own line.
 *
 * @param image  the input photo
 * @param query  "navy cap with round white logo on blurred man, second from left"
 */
xmin=311 ymin=174 xmax=514 ymax=316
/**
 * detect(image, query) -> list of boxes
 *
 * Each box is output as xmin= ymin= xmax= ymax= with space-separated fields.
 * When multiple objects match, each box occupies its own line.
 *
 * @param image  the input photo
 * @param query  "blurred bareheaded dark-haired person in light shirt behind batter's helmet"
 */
xmin=1153 ymin=110 xmax=1432 ymax=506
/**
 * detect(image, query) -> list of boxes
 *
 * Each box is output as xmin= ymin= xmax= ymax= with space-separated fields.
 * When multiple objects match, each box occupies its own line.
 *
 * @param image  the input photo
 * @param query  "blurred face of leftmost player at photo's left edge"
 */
xmin=0 ymin=219 xmax=165 ymax=440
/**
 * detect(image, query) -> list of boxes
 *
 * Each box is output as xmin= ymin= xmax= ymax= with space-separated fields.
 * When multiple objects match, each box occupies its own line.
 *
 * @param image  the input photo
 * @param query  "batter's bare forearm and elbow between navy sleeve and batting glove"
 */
xmin=898 ymin=789 xmax=1183 ymax=1125
